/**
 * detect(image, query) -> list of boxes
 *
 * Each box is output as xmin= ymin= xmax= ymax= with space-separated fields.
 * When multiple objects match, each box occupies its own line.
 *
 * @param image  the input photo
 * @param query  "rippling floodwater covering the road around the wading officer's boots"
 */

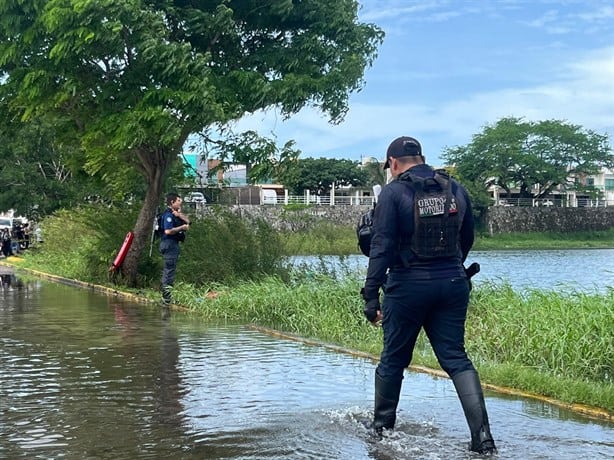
xmin=0 ymin=275 xmax=614 ymax=460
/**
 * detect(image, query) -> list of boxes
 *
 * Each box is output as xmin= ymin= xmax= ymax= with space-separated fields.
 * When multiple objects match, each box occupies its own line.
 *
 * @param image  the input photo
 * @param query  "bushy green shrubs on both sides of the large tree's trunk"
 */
xmin=19 ymin=206 xmax=283 ymax=288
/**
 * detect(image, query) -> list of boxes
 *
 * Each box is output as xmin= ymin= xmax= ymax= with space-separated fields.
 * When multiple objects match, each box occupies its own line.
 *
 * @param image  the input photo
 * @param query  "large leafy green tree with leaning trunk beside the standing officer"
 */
xmin=0 ymin=0 xmax=383 ymax=285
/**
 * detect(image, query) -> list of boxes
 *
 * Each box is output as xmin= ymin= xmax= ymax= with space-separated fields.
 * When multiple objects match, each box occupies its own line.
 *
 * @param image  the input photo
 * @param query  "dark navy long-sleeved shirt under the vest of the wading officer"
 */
xmin=363 ymin=164 xmax=474 ymax=300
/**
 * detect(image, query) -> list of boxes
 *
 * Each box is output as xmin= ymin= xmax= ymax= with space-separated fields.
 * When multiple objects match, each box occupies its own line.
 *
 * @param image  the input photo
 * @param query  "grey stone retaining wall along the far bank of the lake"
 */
xmin=209 ymin=205 xmax=614 ymax=235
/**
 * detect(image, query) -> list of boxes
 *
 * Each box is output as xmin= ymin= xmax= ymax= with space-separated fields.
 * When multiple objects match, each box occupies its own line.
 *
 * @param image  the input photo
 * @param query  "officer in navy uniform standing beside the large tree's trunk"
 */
xmin=160 ymin=193 xmax=190 ymax=305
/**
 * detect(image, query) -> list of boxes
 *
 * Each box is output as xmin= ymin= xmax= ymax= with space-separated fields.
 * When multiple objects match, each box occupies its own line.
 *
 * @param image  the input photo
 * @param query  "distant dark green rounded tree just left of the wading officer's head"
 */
xmin=279 ymin=158 xmax=368 ymax=195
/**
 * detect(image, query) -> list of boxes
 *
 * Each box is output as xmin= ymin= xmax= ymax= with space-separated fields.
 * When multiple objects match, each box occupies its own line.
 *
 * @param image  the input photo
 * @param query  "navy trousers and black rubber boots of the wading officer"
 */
xmin=373 ymin=272 xmax=494 ymax=452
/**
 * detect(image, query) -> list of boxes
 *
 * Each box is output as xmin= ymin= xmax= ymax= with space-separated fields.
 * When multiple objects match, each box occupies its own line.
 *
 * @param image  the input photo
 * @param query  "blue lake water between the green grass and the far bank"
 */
xmin=290 ymin=249 xmax=614 ymax=292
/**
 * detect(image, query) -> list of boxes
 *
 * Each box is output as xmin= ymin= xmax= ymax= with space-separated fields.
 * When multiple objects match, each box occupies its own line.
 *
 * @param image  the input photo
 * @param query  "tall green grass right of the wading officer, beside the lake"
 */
xmin=467 ymin=284 xmax=614 ymax=384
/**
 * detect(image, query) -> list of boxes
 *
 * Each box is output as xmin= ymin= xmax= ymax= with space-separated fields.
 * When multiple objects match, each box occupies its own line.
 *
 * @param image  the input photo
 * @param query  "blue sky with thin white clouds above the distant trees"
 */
xmin=237 ymin=0 xmax=614 ymax=166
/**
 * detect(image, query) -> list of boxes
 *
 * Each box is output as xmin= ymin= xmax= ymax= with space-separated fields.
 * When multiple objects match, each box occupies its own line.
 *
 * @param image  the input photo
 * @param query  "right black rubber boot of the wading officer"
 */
xmin=452 ymin=370 xmax=497 ymax=454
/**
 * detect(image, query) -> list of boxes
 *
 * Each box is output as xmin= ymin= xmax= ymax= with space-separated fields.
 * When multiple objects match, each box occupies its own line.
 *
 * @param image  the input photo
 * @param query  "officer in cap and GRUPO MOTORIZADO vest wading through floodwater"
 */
xmin=361 ymin=137 xmax=496 ymax=454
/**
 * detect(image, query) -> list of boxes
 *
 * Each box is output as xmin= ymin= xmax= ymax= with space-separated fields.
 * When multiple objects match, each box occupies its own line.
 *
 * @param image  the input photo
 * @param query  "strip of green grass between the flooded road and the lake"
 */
xmin=170 ymin=277 xmax=614 ymax=411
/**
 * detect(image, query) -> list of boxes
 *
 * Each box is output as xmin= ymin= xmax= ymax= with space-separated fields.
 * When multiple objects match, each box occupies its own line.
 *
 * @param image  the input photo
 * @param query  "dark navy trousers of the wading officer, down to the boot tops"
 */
xmin=377 ymin=273 xmax=474 ymax=381
